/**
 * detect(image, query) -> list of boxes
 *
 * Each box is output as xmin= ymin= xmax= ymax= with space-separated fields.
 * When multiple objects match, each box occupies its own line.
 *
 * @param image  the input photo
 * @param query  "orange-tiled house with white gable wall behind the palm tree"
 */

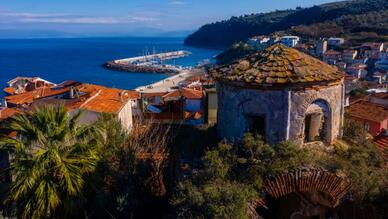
xmin=4 ymin=78 xmax=139 ymax=129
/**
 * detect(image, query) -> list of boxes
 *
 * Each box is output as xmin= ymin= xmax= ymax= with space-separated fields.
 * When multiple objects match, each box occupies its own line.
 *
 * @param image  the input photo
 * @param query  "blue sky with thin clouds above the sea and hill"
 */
xmin=0 ymin=0 xmax=333 ymax=35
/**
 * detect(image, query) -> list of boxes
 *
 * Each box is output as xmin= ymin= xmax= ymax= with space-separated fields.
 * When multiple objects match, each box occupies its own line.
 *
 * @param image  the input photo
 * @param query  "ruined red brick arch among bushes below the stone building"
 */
xmin=257 ymin=168 xmax=351 ymax=219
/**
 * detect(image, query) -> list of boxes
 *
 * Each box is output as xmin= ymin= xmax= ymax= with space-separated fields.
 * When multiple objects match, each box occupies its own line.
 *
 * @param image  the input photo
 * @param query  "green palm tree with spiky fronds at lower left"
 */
xmin=0 ymin=106 xmax=99 ymax=218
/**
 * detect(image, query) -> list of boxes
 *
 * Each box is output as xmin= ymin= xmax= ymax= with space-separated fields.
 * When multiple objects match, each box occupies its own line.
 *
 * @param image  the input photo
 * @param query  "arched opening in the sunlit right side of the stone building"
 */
xmin=303 ymin=99 xmax=332 ymax=143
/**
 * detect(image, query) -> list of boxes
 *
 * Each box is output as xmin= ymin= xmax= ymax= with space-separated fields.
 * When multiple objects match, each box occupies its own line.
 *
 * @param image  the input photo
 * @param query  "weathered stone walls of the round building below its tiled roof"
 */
xmin=216 ymin=82 xmax=344 ymax=144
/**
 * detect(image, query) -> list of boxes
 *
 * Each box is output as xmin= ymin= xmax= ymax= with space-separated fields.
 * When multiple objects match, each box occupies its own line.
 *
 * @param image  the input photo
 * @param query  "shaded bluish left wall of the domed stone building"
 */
xmin=216 ymin=82 xmax=289 ymax=143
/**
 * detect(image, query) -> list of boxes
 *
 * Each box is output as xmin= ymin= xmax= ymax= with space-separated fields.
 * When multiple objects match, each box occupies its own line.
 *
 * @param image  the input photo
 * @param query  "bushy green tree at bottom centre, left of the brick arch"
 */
xmin=171 ymin=143 xmax=258 ymax=218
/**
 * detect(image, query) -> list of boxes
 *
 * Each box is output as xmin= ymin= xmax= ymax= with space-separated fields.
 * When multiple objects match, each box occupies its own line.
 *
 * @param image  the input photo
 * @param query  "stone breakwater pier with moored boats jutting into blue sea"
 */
xmin=103 ymin=50 xmax=191 ymax=74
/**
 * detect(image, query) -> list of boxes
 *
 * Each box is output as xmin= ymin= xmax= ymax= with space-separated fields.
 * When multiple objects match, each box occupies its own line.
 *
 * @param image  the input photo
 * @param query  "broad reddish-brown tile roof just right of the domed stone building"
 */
xmin=346 ymin=100 xmax=388 ymax=123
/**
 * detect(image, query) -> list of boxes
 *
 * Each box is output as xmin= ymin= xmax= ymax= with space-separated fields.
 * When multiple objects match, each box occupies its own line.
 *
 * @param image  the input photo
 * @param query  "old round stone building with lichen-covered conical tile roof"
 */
xmin=210 ymin=44 xmax=345 ymax=144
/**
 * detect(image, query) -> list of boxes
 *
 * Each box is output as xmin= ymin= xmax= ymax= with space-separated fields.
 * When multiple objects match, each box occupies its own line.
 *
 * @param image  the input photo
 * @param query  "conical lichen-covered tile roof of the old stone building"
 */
xmin=210 ymin=44 xmax=344 ymax=86
